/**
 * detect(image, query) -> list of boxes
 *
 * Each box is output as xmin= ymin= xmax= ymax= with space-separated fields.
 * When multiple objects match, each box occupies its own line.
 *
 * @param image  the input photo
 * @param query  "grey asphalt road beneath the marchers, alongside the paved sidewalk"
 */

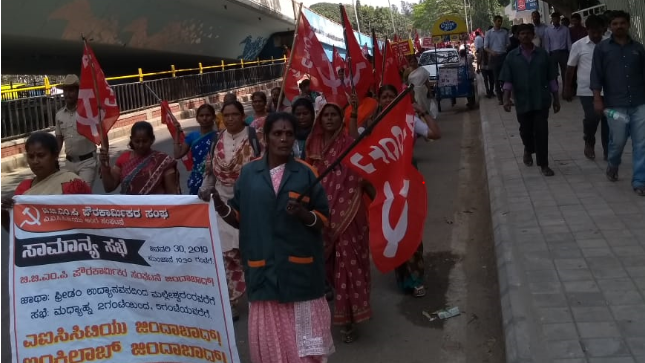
xmin=2 ymin=100 xmax=504 ymax=363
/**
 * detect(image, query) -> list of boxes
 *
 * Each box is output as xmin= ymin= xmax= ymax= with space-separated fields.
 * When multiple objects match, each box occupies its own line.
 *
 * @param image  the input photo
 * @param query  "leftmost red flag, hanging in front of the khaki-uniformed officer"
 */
xmin=76 ymin=42 xmax=121 ymax=145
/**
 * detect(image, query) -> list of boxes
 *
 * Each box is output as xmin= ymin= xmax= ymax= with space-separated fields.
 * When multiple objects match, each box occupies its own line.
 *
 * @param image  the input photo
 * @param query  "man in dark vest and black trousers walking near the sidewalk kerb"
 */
xmin=500 ymin=24 xmax=560 ymax=176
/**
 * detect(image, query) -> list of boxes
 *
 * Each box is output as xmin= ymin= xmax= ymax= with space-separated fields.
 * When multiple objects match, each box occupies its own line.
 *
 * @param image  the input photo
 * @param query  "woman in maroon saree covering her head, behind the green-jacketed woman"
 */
xmin=305 ymin=103 xmax=372 ymax=343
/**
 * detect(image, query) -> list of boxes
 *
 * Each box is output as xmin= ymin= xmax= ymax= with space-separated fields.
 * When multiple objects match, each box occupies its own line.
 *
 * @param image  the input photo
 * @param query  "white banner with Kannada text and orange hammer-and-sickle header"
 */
xmin=9 ymin=195 xmax=239 ymax=363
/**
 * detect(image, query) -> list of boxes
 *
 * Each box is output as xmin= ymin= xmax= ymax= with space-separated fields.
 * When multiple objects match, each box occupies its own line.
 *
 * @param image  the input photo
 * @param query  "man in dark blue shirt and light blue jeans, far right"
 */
xmin=591 ymin=11 xmax=645 ymax=196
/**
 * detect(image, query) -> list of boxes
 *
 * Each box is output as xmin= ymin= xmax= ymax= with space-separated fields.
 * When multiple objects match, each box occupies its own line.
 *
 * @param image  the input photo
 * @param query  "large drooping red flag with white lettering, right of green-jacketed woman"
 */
xmin=343 ymin=97 xmax=428 ymax=273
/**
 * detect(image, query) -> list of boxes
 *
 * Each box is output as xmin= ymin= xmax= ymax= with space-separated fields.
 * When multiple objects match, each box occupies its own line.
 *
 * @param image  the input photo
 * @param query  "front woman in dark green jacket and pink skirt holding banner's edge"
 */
xmin=202 ymin=113 xmax=334 ymax=363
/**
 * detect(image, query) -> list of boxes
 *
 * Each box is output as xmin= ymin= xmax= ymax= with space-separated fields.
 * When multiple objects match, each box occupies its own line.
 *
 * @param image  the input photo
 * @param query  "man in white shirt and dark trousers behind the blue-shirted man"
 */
xmin=563 ymin=15 xmax=609 ymax=160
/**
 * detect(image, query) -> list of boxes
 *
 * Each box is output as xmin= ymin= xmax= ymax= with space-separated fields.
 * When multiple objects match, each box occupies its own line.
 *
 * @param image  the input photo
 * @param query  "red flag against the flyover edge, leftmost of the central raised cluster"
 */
xmin=284 ymin=14 xmax=343 ymax=103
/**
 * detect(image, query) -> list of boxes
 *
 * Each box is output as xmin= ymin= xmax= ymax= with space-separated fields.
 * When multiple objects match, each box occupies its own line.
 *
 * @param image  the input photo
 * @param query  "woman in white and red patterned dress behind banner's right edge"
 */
xmin=200 ymin=101 xmax=261 ymax=320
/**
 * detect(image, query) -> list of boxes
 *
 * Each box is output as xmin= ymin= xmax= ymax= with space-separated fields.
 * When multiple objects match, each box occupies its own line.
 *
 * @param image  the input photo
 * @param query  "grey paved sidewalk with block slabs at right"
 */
xmin=480 ymin=98 xmax=645 ymax=363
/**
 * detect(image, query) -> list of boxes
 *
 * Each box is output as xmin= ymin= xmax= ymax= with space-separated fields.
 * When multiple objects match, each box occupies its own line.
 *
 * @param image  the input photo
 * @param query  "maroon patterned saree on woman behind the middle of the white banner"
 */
xmin=116 ymin=150 xmax=181 ymax=195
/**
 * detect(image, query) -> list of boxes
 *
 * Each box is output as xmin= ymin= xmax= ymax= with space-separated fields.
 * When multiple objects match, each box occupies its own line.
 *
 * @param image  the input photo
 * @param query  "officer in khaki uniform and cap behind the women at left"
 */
xmin=55 ymin=74 xmax=98 ymax=188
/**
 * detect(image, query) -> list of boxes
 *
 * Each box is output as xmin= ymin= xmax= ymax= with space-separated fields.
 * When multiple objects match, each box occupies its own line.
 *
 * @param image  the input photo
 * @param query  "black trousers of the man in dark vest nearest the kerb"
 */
xmin=517 ymin=108 xmax=549 ymax=166
